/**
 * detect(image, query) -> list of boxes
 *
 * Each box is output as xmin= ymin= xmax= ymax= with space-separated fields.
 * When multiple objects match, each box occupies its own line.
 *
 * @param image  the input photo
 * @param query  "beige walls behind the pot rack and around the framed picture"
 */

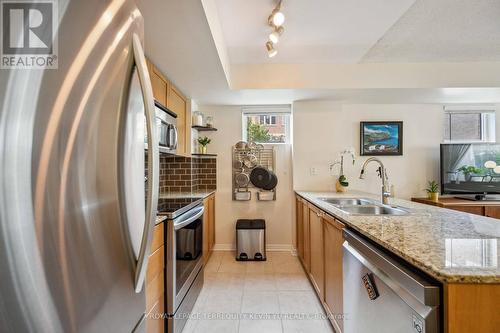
xmin=200 ymin=101 xmax=500 ymax=249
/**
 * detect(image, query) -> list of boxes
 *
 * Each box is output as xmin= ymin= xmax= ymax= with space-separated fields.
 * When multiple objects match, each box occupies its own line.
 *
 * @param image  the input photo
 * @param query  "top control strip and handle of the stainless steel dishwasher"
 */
xmin=343 ymin=229 xmax=440 ymax=306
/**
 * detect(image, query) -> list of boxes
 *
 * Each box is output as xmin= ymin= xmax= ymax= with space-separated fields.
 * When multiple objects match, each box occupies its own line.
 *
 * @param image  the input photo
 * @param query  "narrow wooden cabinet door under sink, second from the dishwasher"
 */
xmin=309 ymin=205 xmax=325 ymax=301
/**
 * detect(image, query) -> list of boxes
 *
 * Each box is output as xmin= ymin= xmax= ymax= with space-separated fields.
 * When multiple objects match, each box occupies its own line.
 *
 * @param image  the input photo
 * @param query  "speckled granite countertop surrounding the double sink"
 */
xmin=296 ymin=191 xmax=500 ymax=283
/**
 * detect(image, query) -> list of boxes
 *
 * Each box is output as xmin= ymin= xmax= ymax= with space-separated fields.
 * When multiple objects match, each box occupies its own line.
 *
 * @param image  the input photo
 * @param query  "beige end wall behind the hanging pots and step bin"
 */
xmin=199 ymin=106 xmax=294 ymax=249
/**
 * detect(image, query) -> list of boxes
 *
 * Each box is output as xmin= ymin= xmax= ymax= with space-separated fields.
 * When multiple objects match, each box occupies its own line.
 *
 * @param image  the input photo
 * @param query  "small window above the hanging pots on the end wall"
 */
xmin=242 ymin=105 xmax=291 ymax=143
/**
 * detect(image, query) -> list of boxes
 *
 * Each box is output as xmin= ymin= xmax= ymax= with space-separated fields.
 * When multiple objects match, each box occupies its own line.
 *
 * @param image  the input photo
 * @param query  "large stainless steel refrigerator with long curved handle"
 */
xmin=0 ymin=0 xmax=159 ymax=333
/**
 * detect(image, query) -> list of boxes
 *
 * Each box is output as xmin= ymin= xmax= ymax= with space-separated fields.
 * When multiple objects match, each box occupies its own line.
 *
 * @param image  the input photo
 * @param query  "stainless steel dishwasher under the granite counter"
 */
xmin=343 ymin=230 xmax=440 ymax=333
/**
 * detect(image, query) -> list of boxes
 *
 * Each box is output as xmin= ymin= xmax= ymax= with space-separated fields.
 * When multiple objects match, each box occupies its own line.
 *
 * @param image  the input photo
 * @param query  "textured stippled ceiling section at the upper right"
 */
xmin=363 ymin=0 xmax=500 ymax=62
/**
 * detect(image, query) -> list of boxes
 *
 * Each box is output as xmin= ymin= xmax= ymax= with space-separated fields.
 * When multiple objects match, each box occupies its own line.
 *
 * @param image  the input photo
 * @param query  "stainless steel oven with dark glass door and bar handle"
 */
xmin=166 ymin=202 xmax=204 ymax=333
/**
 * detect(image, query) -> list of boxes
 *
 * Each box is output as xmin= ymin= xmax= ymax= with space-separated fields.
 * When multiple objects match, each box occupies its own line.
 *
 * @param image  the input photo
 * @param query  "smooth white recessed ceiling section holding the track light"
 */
xmin=215 ymin=0 xmax=415 ymax=64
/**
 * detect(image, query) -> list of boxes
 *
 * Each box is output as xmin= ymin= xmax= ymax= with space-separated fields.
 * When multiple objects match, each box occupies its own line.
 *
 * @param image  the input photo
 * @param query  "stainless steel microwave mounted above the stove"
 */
xmin=155 ymin=101 xmax=178 ymax=154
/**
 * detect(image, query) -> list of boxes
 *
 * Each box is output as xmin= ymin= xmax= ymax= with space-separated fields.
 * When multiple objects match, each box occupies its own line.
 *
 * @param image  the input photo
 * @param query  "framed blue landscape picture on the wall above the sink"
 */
xmin=359 ymin=121 xmax=403 ymax=156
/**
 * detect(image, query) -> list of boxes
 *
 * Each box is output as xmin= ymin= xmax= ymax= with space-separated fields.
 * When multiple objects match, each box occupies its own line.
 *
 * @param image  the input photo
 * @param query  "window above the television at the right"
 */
xmin=444 ymin=106 xmax=495 ymax=142
